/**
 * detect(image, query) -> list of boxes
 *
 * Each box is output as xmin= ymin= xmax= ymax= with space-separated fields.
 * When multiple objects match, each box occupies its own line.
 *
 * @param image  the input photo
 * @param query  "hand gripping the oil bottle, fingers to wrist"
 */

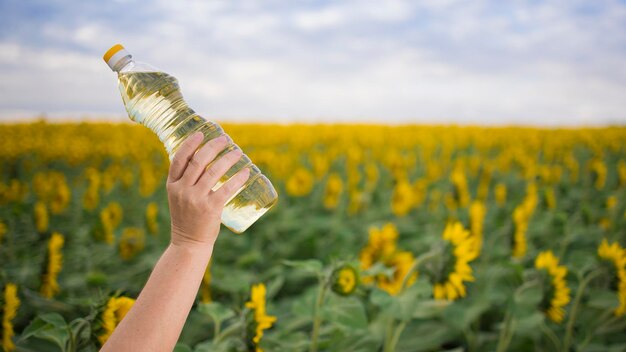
xmin=167 ymin=132 xmax=250 ymax=248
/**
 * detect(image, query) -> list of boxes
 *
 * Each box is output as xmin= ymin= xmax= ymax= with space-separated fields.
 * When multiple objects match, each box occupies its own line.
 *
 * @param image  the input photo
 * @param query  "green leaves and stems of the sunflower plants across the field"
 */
xmin=0 ymin=123 xmax=626 ymax=352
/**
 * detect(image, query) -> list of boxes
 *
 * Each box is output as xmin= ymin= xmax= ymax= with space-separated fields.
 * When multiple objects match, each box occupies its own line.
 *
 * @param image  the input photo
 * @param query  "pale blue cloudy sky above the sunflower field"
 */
xmin=0 ymin=0 xmax=626 ymax=126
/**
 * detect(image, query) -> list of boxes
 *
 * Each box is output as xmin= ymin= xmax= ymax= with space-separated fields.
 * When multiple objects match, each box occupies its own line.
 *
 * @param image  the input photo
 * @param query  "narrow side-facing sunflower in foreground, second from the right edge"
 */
xmin=535 ymin=251 xmax=571 ymax=323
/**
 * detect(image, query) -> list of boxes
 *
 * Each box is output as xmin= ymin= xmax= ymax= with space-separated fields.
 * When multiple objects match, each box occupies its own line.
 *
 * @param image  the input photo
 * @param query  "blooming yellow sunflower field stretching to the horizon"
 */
xmin=0 ymin=120 xmax=626 ymax=352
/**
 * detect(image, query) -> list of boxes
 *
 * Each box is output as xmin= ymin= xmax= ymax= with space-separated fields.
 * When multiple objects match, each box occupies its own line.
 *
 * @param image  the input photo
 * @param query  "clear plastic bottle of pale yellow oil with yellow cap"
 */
xmin=104 ymin=44 xmax=278 ymax=233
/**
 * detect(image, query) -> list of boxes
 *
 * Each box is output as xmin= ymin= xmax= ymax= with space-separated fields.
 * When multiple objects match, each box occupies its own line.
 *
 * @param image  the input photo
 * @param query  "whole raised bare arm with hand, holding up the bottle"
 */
xmin=101 ymin=133 xmax=249 ymax=352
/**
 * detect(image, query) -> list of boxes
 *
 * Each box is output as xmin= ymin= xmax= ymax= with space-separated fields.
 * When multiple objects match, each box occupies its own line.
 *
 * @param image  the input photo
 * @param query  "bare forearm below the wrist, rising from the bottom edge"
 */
xmin=102 ymin=245 xmax=213 ymax=351
